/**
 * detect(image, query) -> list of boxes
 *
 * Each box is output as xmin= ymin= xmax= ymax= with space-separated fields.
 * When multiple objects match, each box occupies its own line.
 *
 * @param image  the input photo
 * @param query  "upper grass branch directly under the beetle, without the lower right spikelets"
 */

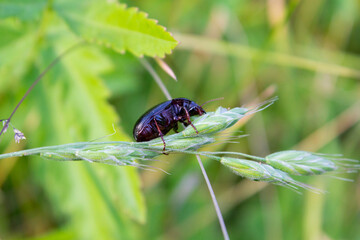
xmin=0 ymin=104 xmax=268 ymax=165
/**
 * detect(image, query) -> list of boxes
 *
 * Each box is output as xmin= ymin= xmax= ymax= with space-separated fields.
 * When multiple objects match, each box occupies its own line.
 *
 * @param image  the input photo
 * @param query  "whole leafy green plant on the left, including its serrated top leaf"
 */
xmin=0 ymin=0 xmax=177 ymax=239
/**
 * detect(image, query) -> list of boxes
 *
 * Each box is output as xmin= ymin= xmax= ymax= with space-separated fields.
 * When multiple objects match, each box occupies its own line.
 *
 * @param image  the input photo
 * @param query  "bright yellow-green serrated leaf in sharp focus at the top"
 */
xmin=54 ymin=0 xmax=177 ymax=57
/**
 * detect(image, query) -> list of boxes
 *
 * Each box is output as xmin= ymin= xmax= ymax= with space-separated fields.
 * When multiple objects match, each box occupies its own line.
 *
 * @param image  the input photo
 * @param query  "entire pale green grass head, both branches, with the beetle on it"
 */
xmin=0 ymin=98 xmax=359 ymax=192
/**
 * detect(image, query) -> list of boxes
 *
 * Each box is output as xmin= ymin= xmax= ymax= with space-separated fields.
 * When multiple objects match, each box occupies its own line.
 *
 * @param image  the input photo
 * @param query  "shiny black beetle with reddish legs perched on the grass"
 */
xmin=133 ymin=98 xmax=206 ymax=151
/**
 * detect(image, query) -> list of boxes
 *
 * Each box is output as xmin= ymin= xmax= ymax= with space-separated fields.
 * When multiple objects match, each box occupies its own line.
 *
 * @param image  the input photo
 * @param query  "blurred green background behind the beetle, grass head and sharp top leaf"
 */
xmin=0 ymin=0 xmax=360 ymax=239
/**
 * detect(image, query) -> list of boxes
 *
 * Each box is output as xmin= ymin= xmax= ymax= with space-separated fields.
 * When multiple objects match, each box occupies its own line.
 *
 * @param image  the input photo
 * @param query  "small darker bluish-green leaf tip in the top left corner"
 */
xmin=0 ymin=0 xmax=47 ymax=20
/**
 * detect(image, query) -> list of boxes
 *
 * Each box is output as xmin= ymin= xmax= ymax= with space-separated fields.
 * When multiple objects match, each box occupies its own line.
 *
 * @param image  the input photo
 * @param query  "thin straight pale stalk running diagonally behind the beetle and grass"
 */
xmin=140 ymin=58 xmax=230 ymax=240
